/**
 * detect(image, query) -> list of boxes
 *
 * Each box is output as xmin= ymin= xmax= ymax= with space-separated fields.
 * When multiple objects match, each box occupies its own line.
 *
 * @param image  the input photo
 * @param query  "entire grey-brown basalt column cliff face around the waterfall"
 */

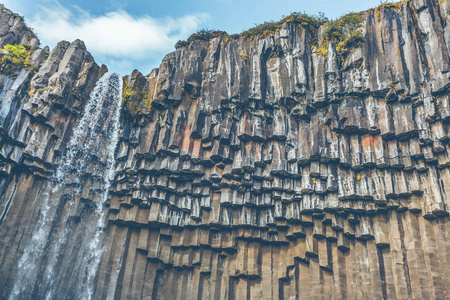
xmin=0 ymin=0 xmax=450 ymax=299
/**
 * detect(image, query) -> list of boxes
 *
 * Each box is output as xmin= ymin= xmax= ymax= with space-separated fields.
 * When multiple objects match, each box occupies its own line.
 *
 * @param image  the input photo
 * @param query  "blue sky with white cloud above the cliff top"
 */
xmin=0 ymin=0 xmax=390 ymax=75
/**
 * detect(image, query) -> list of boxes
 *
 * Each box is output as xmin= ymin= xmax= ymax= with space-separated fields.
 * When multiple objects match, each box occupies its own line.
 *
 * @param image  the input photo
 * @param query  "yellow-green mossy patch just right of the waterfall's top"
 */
xmin=122 ymin=78 xmax=153 ymax=116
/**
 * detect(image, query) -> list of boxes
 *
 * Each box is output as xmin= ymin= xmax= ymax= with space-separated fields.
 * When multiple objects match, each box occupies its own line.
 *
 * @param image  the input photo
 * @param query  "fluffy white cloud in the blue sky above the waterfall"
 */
xmin=28 ymin=1 xmax=209 ymax=59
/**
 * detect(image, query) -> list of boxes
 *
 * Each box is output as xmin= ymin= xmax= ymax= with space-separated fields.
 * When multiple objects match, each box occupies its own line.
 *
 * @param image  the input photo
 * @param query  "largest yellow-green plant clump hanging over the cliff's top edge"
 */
xmin=316 ymin=12 xmax=365 ymax=58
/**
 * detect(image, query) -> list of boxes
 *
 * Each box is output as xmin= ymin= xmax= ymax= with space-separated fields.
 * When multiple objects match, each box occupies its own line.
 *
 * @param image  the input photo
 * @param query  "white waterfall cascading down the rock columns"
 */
xmin=10 ymin=73 xmax=122 ymax=299
